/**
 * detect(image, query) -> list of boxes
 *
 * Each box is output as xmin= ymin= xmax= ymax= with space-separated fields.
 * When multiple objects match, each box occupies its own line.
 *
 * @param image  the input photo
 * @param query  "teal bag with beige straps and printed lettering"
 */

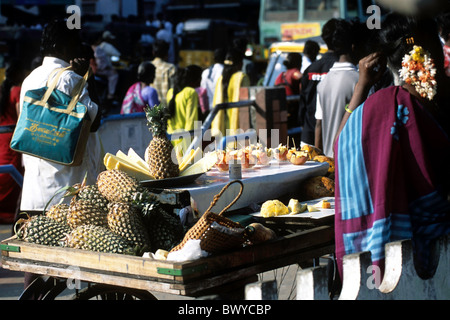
xmin=11 ymin=66 xmax=92 ymax=166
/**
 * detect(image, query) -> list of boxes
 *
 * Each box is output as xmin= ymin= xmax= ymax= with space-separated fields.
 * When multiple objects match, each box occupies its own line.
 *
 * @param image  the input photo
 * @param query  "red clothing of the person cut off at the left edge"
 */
xmin=0 ymin=86 xmax=23 ymax=223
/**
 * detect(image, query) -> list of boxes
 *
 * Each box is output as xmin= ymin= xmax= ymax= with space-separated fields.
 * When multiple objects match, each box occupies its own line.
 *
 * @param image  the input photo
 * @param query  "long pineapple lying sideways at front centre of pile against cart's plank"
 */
xmin=64 ymin=225 xmax=137 ymax=255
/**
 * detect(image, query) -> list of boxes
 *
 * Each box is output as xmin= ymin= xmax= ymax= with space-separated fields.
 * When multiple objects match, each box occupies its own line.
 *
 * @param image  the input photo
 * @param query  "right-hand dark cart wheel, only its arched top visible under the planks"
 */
xmin=72 ymin=284 xmax=156 ymax=300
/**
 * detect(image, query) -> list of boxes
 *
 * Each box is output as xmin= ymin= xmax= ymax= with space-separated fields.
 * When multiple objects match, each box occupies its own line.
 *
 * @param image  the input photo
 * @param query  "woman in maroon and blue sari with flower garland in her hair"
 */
xmin=335 ymin=14 xmax=450 ymax=277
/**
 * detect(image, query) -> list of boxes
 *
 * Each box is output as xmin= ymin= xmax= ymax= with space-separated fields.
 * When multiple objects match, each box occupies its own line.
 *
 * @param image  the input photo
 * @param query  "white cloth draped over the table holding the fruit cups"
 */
xmin=160 ymin=160 xmax=329 ymax=213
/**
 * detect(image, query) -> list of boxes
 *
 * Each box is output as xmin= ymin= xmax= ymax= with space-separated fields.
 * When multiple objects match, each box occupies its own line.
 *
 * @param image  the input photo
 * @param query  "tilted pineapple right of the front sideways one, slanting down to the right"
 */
xmin=107 ymin=202 xmax=150 ymax=250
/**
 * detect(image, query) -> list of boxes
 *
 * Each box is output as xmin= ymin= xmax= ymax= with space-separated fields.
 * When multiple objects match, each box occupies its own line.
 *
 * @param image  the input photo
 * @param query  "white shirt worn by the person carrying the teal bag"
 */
xmin=20 ymin=57 xmax=103 ymax=211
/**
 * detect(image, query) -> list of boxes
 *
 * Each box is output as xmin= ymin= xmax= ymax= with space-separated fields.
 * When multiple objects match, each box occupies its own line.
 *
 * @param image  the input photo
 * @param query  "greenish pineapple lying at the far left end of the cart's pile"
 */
xmin=16 ymin=215 xmax=70 ymax=246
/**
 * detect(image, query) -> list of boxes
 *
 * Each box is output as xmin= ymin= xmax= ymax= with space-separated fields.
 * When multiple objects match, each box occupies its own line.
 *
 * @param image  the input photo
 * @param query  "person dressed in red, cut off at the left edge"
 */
xmin=0 ymin=60 xmax=25 ymax=224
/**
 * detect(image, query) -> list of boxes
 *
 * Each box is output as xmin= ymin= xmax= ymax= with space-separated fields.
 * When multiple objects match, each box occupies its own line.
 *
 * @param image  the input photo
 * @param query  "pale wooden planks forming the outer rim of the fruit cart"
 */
xmin=2 ymin=226 xmax=334 ymax=290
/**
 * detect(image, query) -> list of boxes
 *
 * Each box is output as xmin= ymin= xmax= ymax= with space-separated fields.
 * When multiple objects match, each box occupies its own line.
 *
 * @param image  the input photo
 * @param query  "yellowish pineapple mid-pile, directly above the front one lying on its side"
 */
xmin=67 ymin=198 xmax=108 ymax=229
